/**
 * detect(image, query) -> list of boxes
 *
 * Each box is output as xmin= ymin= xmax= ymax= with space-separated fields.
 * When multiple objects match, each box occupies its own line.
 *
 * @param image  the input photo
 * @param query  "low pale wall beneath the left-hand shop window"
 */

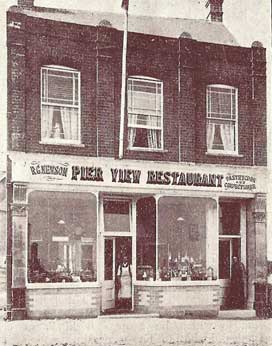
xmin=26 ymin=287 xmax=101 ymax=319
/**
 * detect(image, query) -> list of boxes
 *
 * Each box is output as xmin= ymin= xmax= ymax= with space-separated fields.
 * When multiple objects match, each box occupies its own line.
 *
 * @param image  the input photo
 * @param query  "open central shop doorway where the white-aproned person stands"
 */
xmin=102 ymin=236 xmax=133 ymax=313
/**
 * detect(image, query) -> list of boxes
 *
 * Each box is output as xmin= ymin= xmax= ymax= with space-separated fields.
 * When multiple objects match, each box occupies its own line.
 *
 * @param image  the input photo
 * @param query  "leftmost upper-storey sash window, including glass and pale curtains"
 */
xmin=41 ymin=66 xmax=80 ymax=144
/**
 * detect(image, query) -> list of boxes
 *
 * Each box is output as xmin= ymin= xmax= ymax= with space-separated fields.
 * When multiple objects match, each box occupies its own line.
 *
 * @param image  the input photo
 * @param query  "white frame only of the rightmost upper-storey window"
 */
xmin=206 ymin=84 xmax=239 ymax=156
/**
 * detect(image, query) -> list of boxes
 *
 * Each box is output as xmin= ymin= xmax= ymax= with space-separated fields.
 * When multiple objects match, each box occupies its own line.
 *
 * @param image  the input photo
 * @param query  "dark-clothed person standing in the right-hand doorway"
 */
xmin=229 ymin=256 xmax=246 ymax=309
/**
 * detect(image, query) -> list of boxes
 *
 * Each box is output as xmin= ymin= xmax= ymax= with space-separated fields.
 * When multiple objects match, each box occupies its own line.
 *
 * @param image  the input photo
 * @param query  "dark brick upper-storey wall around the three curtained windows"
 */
xmin=8 ymin=11 xmax=266 ymax=165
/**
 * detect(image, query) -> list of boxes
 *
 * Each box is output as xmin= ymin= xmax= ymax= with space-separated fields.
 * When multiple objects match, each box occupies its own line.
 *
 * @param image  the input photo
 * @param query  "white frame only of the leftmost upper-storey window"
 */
xmin=40 ymin=65 xmax=81 ymax=145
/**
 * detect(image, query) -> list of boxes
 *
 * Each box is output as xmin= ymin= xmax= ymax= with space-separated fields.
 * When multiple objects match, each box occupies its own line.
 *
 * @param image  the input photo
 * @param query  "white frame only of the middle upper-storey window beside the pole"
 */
xmin=127 ymin=76 xmax=164 ymax=152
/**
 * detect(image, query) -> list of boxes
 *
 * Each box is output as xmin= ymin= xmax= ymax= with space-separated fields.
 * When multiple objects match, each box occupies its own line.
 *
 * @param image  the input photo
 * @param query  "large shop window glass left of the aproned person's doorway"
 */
xmin=28 ymin=191 xmax=97 ymax=283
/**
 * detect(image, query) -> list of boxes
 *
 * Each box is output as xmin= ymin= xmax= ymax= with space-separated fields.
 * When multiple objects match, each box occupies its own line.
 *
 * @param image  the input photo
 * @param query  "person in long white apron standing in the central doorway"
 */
xmin=117 ymin=255 xmax=132 ymax=309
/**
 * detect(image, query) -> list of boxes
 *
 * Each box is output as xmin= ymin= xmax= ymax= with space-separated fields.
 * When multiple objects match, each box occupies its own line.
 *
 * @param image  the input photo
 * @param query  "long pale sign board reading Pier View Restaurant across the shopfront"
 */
xmin=9 ymin=154 xmax=266 ymax=193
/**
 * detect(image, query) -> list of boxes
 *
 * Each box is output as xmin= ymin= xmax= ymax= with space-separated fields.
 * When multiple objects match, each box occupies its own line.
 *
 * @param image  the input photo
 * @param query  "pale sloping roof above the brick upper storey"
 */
xmin=10 ymin=6 xmax=238 ymax=46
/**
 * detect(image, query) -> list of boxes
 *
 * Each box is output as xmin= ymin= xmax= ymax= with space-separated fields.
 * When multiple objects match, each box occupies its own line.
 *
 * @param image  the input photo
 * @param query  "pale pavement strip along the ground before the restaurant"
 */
xmin=0 ymin=316 xmax=272 ymax=346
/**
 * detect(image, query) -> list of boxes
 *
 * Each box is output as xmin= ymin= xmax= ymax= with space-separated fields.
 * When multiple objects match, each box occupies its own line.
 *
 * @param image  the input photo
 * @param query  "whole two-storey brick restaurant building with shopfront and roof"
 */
xmin=7 ymin=0 xmax=267 ymax=319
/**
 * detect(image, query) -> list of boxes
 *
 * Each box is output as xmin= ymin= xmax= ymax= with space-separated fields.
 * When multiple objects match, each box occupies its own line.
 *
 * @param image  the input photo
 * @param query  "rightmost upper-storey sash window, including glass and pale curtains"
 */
xmin=207 ymin=85 xmax=238 ymax=154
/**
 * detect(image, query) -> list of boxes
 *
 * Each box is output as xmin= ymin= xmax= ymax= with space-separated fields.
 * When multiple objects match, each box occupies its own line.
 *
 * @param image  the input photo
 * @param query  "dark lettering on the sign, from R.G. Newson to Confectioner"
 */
xmin=29 ymin=161 xmax=256 ymax=192
